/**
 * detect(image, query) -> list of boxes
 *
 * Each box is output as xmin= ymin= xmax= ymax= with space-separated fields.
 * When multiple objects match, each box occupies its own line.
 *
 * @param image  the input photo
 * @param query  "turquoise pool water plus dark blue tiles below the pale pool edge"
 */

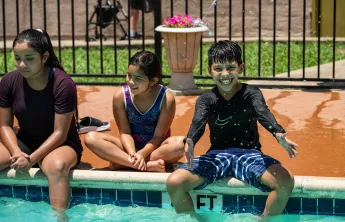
xmin=0 ymin=185 xmax=345 ymax=222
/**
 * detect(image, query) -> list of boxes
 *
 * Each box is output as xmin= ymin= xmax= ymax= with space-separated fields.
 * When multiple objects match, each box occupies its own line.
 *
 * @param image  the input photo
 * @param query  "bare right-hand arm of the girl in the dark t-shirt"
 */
xmin=30 ymin=111 xmax=74 ymax=165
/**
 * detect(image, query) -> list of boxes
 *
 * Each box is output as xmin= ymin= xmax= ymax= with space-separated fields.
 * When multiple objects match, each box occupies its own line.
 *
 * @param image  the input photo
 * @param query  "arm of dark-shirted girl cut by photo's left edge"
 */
xmin=0 ymin=108 xmax=22 ymax=156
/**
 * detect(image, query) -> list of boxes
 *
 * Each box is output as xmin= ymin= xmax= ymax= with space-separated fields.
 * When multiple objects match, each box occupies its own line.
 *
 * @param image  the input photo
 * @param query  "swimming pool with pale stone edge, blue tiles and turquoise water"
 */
xmin=0 ymin=169 xmax=345 ymax=222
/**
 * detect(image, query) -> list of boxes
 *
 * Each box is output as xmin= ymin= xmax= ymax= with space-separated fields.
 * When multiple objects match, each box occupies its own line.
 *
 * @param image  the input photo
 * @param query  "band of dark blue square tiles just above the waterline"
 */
xmin=0 ymin=185 xmax=345 ymax=215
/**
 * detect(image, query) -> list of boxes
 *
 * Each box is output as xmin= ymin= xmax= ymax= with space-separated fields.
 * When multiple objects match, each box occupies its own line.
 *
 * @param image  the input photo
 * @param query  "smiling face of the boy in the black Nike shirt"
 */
xmin=209 ymin=61 xmax=244 ymax=92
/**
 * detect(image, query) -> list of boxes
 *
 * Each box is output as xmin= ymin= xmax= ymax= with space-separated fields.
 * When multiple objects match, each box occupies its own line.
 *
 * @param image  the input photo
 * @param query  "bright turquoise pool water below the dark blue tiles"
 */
xmin=0 ymin=197 xmax=345 ymax=222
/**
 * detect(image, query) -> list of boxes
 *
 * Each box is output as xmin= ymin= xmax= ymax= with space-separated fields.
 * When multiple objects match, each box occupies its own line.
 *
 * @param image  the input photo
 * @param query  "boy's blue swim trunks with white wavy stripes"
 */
xmin=179 ymin=148 xmax=280 ymax=192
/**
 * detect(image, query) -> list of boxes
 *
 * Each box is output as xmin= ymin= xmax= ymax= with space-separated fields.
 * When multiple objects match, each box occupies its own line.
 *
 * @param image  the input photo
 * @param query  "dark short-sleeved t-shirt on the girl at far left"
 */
xmin=0 ymin=68 xmax=81 ymax=150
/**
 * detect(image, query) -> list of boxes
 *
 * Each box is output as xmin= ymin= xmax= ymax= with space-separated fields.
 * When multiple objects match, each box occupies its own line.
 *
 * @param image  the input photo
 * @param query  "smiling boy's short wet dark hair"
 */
xmin=208 ymin=40 xmax=242 ymax=67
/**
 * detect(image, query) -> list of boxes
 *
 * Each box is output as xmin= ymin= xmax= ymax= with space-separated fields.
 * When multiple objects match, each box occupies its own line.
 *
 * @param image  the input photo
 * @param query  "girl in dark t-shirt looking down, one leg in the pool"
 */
xmin=0 ymin=29 xmax=83 ymax=210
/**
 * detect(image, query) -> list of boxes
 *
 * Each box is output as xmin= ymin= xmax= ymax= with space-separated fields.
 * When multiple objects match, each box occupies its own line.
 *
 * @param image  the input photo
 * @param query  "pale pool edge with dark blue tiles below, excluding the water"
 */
xmin=0 ymin=169 xmax=345 ymax=215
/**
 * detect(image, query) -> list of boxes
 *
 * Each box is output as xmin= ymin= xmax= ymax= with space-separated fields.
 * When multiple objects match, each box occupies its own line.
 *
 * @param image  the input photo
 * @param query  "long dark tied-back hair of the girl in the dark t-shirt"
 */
xmin=12 ymin=29 xmax=80 ymax=131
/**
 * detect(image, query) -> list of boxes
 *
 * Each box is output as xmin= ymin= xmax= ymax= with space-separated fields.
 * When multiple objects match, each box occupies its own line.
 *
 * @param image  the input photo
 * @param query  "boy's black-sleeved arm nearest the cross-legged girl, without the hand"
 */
xmin=186 ymin=94 xmax=208 ymax=146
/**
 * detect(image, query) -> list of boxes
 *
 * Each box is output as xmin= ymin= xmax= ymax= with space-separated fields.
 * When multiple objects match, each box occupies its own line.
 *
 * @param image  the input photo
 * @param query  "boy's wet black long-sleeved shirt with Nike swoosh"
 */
xmin=187 ymin=84 xmax=285 ymax=151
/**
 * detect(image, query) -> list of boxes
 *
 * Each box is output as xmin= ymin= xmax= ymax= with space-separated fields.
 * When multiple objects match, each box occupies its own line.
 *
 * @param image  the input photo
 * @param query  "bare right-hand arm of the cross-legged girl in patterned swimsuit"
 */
xmin=138 ymin=91 xmax=176 ymax=158
